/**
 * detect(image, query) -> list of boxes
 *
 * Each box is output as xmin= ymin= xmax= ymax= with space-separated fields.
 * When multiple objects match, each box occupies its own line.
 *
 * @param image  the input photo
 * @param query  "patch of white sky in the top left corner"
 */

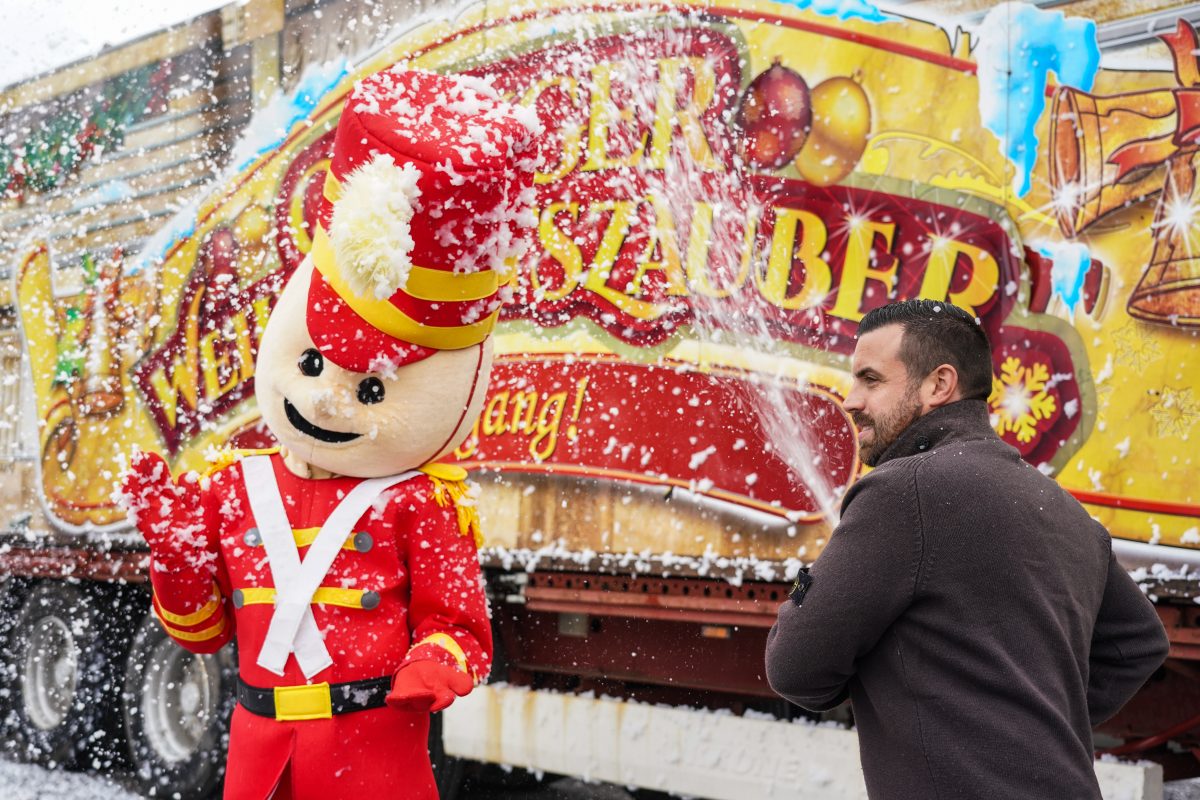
xmin=0 ymin=0 xmax=230 ymax=86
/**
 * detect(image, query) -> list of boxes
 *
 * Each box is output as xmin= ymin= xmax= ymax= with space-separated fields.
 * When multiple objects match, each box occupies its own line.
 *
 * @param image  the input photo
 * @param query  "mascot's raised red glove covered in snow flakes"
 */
xmin=121 ymin=450 xmax=216 ymax=575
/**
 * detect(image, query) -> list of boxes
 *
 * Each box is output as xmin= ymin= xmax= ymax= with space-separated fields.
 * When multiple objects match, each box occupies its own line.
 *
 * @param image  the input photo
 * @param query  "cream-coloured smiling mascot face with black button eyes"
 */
xmin=254 ymin=259 xmax=492 ymax=477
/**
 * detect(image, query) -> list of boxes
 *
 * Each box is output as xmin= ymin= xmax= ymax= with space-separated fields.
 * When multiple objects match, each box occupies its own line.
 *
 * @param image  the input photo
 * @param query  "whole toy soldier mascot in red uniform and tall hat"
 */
xmin=125 ymin=68 xmax=536 ymax=800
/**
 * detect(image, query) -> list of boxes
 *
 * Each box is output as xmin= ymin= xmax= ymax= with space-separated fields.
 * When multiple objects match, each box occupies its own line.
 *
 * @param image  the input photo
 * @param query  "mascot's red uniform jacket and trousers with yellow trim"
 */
xmin=150 ymin=451 xmax=492 ymax=800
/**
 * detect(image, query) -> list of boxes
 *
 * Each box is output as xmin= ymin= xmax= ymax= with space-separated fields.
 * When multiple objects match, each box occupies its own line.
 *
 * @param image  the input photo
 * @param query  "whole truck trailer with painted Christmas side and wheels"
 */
xmin=0 ymin=0 xmax=1200 ymax=798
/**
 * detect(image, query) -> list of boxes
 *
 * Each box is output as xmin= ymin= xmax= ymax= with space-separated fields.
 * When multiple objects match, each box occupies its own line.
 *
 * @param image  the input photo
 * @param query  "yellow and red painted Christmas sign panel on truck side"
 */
xmin=8 ymin=2 xmax=1200 ymax=582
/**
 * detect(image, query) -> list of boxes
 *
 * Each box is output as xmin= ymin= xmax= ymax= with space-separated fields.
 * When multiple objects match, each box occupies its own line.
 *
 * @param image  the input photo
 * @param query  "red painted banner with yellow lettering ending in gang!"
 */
xmin=455 ymin=356 xmax=858 ymax=521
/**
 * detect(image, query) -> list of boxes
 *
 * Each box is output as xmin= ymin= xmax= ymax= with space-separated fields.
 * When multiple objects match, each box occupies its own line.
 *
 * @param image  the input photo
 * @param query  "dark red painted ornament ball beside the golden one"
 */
xmin=737 ymin=59 xmax=812 ymax=169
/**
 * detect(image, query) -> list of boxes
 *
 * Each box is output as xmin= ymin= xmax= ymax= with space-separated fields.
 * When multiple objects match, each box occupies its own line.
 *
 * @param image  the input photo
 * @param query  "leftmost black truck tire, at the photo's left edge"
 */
xmin=4 ymin=581 xmax=126 ymax=768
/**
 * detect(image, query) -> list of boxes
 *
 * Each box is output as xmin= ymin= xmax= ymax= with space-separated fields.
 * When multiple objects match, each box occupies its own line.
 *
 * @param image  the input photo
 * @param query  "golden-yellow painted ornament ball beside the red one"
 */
xmin=796 ymin=77 xmax=871 ymax=186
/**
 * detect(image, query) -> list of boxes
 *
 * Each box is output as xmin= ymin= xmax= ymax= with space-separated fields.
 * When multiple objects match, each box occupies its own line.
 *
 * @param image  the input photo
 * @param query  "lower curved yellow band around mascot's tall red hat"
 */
xmin=312 ymin=225 xmax=500 ymax=350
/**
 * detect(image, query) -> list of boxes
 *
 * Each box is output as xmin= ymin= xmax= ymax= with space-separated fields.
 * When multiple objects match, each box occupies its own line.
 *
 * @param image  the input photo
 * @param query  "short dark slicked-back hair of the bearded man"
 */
xmin=858 ymin=300 xmax=991 ymax=399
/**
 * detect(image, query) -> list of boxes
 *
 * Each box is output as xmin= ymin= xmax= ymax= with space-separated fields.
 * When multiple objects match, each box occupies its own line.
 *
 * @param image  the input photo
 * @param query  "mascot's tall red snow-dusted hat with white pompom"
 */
xmin=307 ymin=66 xmax=538 ymax=372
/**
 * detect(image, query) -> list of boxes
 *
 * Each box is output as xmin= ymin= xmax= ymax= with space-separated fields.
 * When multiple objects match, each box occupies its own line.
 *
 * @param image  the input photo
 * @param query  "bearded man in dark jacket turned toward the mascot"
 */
xmin=767 ymin=300 xmax=1168 ymax=800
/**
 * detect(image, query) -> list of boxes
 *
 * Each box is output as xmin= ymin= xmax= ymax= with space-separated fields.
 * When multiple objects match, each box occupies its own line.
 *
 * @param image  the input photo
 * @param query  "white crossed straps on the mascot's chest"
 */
xmin=241 ymin=456 xmax=420 ymax=678
